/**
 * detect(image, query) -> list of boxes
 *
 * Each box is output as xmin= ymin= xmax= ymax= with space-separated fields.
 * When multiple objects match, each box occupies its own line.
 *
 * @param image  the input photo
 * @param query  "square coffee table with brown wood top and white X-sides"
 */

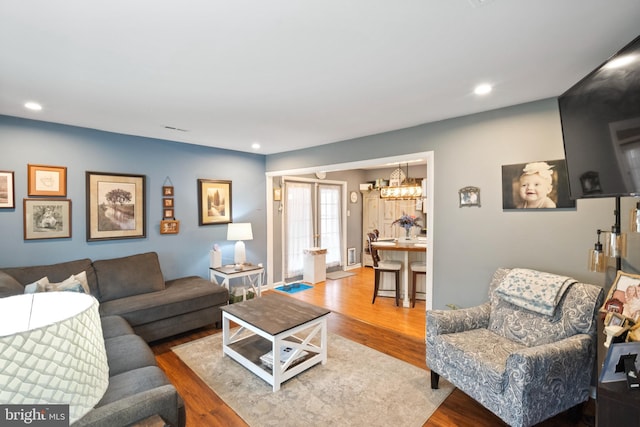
xmin=221 ymin=293 xmax=331 ymax=392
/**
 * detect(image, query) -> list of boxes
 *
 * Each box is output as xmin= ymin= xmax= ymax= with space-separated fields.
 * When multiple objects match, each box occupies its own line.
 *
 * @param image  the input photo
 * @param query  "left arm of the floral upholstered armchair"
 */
xmin=427 ymin=302 xmax=491 ymax=341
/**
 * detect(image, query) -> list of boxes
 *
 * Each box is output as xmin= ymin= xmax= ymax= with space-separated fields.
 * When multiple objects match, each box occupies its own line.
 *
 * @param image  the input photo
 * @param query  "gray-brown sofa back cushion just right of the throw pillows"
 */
xmin=93 ymin=252 xmax=164 ymax=302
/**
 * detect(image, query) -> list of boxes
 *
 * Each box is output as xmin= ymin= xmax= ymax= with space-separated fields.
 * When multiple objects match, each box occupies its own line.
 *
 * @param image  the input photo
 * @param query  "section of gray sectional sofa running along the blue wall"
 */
xmin=0 ymin=252 xmax=229 ymax=342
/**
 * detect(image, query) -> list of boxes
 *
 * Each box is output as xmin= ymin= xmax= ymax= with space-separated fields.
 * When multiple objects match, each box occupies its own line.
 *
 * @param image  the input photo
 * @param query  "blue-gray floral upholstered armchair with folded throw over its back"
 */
xmin=426 ymin=268 xmax=603 ymax=426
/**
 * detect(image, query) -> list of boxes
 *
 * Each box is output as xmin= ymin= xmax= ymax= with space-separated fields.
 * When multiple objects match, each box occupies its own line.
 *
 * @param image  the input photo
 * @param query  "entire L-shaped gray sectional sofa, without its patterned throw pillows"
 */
xmin=0 ymin=252 xmax=229 ymax=427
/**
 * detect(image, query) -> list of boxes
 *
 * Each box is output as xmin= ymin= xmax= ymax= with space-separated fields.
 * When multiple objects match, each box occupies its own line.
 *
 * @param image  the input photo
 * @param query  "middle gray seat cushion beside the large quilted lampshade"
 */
xmin=104 ymin=335 xmax=156 ymax=377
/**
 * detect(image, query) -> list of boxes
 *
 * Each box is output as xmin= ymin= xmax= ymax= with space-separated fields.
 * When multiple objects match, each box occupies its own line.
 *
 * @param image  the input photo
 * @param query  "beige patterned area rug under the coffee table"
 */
xmin=172 ymin=333 xmax=453 ymax=427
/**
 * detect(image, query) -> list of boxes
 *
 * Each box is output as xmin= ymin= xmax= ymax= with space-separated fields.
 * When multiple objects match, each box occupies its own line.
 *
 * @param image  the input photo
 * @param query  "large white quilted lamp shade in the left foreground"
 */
xmin=0 ymin=292 xmax=109 ymax=424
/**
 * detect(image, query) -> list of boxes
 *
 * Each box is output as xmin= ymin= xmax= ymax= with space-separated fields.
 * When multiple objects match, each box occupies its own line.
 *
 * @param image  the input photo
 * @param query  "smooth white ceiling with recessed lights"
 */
xmin=0 ymin=0 xmax=640 ymax=154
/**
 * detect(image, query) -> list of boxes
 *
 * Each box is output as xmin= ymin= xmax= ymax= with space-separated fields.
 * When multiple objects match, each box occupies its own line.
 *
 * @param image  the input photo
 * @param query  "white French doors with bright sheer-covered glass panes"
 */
xmin=283 ymin=181 xmax=343 ymax=278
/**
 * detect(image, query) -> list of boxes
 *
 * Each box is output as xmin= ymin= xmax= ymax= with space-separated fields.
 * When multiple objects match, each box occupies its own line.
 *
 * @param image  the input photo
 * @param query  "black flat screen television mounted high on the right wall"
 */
xmin=558 ymin=37 xmax=640 ymax=199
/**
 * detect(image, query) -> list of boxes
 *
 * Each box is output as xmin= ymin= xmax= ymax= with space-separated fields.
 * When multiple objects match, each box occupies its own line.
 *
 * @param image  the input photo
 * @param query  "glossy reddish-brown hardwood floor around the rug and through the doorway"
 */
xmin=152 ymin=268 xmax=595 ymax=427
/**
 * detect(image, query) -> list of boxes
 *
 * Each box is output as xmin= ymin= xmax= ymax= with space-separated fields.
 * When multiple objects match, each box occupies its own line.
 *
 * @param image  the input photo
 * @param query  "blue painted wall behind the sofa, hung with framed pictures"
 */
xmin=0 ymin=116 xmax=267 ymax=279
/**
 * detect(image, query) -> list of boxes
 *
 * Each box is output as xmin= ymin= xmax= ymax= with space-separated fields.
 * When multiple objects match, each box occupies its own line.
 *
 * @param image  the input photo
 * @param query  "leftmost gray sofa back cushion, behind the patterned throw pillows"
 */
xmin=2 ymin=258 xmax=100 ymax=300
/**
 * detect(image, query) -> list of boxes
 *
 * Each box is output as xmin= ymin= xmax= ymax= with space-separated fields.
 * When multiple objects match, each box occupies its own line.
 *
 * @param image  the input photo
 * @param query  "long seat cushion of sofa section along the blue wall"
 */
xmin=100 ymin=276 xmax=229 ymax=328
